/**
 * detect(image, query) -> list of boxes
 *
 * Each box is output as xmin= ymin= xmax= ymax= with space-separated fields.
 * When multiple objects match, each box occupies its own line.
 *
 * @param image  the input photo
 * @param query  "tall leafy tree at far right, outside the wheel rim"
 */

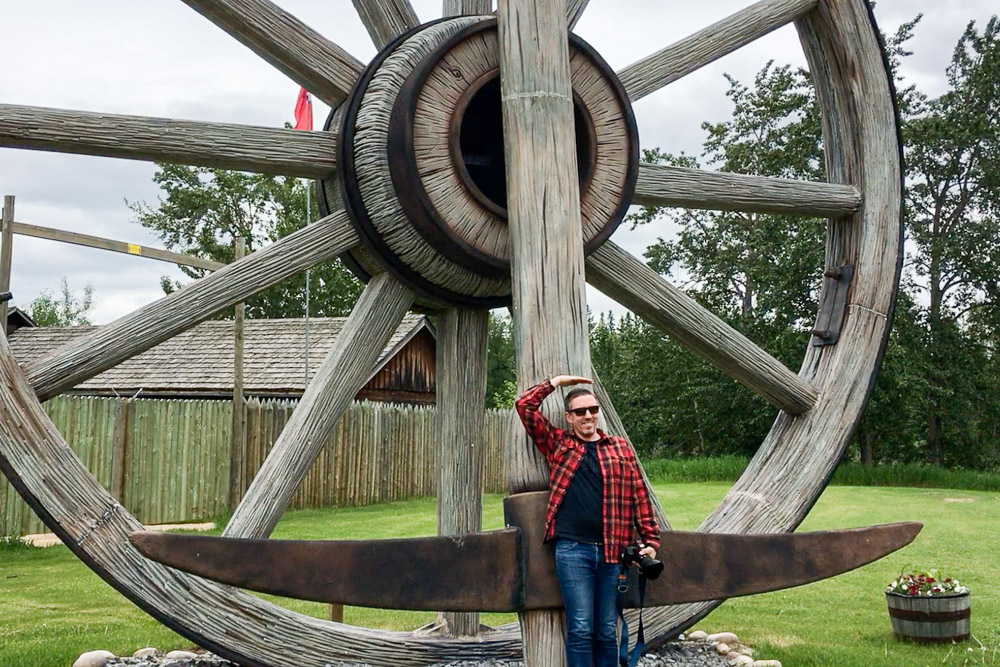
xmin=905 ymin=16 xmax=1000 ymax=465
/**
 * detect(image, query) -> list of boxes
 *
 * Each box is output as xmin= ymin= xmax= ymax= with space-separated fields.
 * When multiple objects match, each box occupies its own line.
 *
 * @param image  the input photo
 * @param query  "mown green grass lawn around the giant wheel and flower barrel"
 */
xmin=0 ymin=483 xmax=1000 ymax=667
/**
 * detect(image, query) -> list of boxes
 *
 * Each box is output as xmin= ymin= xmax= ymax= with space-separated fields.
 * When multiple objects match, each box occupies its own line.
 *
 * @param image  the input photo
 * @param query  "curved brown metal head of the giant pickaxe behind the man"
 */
xmin=129 ymin=491 xmax=922 ymax=611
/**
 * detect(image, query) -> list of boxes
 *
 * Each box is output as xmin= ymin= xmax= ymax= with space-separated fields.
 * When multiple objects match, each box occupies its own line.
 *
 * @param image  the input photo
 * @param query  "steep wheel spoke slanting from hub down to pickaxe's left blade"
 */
xmin=223 ymin=273 xmax=414 ymax=538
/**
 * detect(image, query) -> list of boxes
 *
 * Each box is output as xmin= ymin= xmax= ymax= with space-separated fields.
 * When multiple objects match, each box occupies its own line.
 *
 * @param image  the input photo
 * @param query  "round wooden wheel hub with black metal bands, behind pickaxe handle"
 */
xmin=321 ymin=18 xmax=638 ymax=307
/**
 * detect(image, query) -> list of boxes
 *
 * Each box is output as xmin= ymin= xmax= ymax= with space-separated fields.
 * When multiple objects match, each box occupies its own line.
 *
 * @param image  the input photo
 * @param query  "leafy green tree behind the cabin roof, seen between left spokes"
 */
xmin=129 ymin=164 xmax=361 ymax=317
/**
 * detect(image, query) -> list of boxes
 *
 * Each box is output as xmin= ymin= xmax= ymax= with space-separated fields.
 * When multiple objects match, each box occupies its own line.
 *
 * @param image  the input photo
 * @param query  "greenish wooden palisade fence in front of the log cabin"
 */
xmin=0 ymin=397 xmax=510 ymax=535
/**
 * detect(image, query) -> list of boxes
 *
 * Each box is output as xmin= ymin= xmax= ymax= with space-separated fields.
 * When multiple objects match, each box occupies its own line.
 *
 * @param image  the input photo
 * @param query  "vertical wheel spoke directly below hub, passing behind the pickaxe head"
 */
xmin=435 ymin=308 xmax=489 ymax=637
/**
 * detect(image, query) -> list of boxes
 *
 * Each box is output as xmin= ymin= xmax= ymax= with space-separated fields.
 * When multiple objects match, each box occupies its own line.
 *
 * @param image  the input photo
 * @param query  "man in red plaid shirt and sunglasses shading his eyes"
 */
xmin=516 ymin=375 xmax=660 ymax=667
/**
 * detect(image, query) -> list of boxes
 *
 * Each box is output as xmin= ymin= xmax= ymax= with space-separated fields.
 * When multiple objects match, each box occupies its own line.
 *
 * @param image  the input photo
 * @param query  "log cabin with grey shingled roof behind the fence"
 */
xmin=10 ymin=315 xmax=436 ymax=404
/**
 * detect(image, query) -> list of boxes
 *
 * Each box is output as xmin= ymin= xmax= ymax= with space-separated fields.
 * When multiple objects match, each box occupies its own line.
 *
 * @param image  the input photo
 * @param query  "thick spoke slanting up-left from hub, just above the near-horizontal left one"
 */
xmin=184 ymin=0 xmax=364 ymax=107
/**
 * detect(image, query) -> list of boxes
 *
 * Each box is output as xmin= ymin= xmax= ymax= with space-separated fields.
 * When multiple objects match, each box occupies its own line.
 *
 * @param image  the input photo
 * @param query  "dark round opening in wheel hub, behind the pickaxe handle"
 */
xmin=457 ymin=74 xmax=595 ymax=215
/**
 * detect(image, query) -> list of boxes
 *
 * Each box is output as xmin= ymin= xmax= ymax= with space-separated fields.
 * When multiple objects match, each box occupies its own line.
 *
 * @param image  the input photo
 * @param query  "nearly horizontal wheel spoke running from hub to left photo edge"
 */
xmin=0 ymin=104 xmax=337 ymax=178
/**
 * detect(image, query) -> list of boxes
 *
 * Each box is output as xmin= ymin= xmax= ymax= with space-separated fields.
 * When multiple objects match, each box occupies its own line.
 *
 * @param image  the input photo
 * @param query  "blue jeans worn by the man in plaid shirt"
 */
xmin=555 ymin=539 xmax=619 ymax=667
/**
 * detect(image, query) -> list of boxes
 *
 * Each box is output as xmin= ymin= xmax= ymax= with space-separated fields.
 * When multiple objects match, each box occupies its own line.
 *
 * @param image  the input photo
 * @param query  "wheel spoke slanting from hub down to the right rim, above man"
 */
xmin=587 ymin=242 xmax=818 ymax=415
